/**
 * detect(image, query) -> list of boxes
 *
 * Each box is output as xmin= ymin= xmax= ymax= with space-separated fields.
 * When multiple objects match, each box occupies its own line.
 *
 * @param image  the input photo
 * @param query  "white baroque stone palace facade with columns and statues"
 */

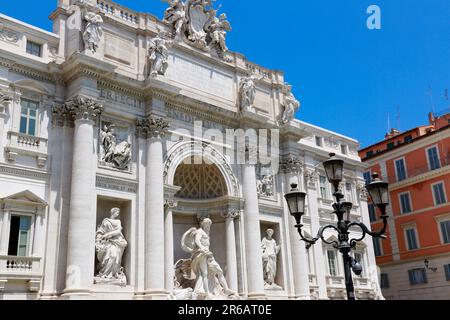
xmin=0 ymin=0 xmax=382 ymax=299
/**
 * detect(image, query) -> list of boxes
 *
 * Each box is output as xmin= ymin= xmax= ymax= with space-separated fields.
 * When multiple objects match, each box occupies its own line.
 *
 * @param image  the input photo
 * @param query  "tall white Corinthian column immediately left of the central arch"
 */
xmin=141 ymin=116 xmax=169 ymax=299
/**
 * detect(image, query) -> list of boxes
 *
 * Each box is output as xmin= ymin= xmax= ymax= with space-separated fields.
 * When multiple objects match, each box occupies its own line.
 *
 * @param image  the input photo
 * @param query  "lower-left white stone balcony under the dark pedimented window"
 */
xmin=0 ymin=256 xmax=42 ymax=292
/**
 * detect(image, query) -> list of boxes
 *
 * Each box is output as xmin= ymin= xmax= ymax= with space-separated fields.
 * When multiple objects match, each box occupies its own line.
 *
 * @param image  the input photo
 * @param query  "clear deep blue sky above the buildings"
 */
xmin=0 ymin=0 xmax=450 ymax=146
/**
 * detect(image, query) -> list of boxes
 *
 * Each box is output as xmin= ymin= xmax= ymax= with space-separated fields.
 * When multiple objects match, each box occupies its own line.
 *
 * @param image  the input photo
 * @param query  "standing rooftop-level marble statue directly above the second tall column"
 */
xmin=148 ymin=34 xmax=172 ymax=78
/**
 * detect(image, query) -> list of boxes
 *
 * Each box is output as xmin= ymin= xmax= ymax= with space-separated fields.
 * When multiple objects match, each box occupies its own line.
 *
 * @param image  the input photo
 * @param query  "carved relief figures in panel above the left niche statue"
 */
xmin=101 ymin=124 xmax=131 ymax=170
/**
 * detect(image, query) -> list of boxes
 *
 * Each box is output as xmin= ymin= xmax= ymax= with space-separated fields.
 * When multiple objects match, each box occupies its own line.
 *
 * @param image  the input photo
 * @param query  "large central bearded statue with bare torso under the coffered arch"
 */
xmin=174 ymin=218 xmax=239 ymax=300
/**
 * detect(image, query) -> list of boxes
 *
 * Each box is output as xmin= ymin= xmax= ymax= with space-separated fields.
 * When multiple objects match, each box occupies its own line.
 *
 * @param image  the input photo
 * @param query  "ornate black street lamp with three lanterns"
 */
xmin=285 ymin=153 xmax=389 ymax=300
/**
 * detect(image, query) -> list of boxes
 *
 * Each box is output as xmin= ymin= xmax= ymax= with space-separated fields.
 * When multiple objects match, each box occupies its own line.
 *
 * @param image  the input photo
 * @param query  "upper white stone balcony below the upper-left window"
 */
xmin=5 ymin=131 xmax=48 ymax=168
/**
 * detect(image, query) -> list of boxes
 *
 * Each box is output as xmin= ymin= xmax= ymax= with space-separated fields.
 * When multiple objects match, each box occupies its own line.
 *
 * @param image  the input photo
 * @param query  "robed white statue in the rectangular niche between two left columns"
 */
xmin=94 ymin=208 xmax=128 ymax=286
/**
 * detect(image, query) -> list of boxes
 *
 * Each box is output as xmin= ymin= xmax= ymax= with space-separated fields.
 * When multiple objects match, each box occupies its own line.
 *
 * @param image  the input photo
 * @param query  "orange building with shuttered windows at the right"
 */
xmin=359 ymin=109 xmax=450 ymax=300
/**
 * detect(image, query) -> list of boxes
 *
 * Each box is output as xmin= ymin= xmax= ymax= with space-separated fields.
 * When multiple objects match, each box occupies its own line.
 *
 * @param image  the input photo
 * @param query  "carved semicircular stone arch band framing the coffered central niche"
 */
xmin=164 ymin=141 xmax=240 ymax=198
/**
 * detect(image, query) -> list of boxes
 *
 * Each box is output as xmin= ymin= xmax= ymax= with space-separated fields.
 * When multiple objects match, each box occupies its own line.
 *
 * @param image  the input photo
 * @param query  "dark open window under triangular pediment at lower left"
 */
xmin=8 ymin=215 xmax=31 ymax=257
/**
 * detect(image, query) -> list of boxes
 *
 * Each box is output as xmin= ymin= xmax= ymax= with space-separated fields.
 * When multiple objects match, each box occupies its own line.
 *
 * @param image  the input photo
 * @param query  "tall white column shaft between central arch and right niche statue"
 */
xmin=242 ymin=146 xmax=265 ymax=299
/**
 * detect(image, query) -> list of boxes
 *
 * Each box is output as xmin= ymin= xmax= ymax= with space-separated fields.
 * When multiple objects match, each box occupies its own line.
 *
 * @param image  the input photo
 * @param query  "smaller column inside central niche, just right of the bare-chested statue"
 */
xmin=222 ymin=210 xmax=240 ymax=292
